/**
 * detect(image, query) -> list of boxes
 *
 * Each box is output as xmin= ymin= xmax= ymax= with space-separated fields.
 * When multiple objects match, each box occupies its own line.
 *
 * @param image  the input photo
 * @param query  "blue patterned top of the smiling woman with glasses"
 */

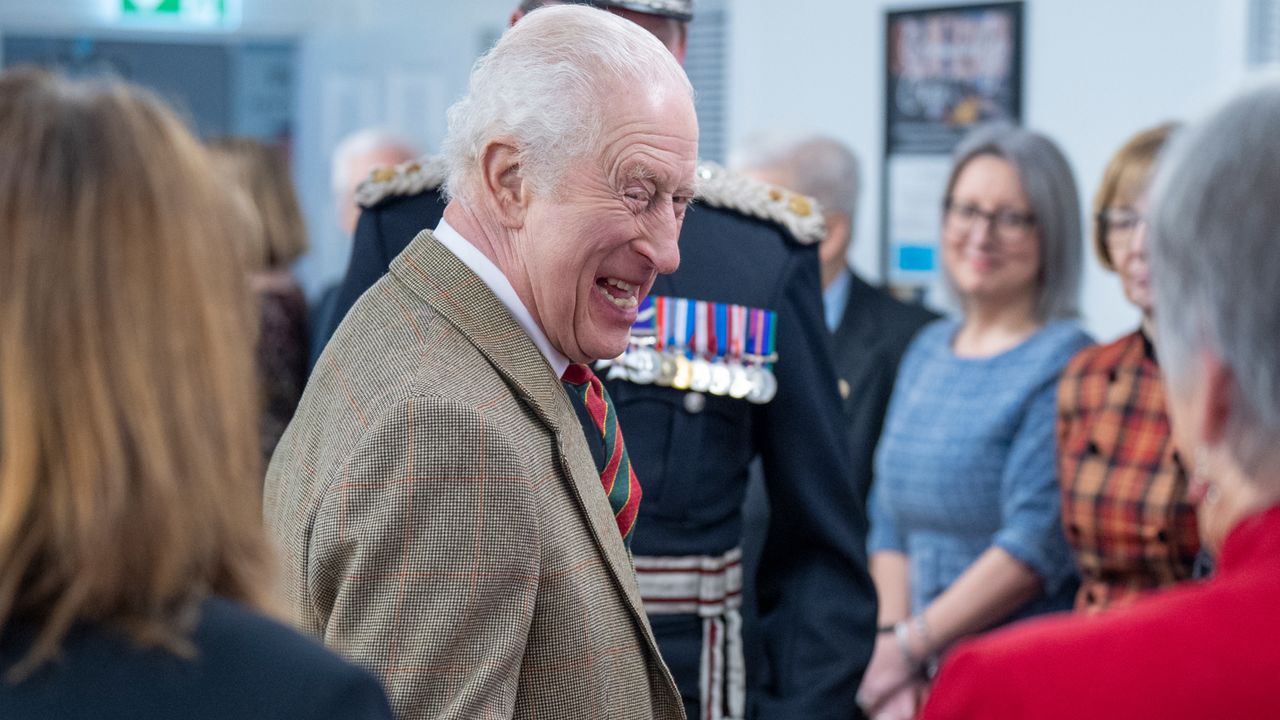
xmin=868 ymin=319 xmax=1092 ymax=619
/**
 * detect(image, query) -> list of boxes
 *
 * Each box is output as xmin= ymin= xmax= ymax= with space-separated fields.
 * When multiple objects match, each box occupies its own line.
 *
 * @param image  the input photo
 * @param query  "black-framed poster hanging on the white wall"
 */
xmin=881 ymin=3 xmax=1023 ymax=300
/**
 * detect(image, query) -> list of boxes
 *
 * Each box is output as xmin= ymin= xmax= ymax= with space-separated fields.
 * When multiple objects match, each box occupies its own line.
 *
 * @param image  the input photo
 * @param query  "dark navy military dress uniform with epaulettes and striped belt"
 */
xmin=320 ymin=159 xmax=876 ymax=719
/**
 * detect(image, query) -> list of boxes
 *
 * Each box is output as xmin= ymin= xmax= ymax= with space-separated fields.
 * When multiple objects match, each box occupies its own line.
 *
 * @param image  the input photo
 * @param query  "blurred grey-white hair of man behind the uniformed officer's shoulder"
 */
xmin=730 ymin=132 xmax=861 ymax=218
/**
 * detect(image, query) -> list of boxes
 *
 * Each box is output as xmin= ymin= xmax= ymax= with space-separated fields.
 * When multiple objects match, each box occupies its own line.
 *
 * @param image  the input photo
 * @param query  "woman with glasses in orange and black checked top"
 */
xmin=1057 ymin=124 xmax=1199 ymax=612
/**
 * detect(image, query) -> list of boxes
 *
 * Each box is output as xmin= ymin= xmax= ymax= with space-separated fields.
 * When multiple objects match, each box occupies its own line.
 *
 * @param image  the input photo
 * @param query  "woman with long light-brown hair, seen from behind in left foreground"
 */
xmin=0 ymin=64 xmax=389 ymax=720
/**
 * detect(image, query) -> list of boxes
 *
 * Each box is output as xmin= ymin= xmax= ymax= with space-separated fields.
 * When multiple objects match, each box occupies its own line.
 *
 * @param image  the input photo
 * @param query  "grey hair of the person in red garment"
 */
xmin=1148 ymin=83 xmax=1280 ymax=473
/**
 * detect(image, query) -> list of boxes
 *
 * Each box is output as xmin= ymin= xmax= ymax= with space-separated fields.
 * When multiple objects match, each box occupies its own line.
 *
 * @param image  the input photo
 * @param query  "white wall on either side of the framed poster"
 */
xmin=730 ymin=0 xmax=1245 ymax=340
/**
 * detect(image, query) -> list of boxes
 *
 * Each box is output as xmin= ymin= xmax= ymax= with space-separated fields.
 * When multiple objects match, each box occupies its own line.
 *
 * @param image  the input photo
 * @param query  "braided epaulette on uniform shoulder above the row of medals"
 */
xmin=698 ymin=163 xmax=827 ymax=245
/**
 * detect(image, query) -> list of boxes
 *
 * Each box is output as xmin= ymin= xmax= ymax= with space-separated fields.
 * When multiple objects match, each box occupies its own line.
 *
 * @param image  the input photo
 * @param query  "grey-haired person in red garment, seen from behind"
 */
xmin=923 ymin=79 xmax=1280 ymax=720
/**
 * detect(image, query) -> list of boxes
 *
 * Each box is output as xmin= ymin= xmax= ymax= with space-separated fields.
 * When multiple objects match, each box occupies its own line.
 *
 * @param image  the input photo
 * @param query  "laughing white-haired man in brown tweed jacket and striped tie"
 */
xmin=265 ymin=6 xmax=698 ymax=719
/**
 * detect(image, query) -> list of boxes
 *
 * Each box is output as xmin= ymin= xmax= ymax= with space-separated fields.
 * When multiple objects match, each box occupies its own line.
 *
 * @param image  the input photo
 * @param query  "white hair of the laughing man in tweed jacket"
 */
xmin=444 ymin=5 xmax=694 ymax=199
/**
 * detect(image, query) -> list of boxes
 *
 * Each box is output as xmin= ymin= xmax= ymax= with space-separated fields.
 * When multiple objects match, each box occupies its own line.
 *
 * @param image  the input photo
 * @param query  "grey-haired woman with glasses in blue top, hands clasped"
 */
xmin=859 ymin=126 xmax=1091 ymax=719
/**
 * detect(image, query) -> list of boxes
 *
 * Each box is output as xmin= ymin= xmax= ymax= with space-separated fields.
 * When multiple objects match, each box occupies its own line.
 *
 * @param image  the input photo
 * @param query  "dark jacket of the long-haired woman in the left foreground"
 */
xmin=0 ymin=598 xmax=392 ymax=720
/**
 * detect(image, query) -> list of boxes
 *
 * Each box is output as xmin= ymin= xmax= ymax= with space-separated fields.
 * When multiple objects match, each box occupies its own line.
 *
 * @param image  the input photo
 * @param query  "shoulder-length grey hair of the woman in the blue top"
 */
xmin=945 ymin=123 xmax=1083 ymax=322
